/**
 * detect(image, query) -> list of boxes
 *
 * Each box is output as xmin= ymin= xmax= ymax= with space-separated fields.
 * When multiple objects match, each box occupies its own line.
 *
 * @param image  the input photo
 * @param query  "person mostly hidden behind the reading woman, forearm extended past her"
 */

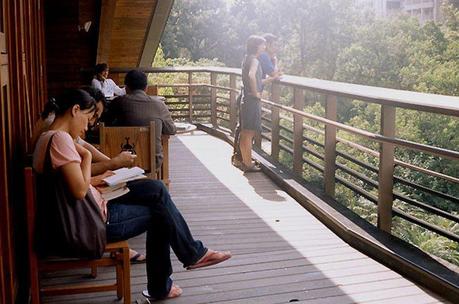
xmin=32 ymin=86 xmax=146 ymax=263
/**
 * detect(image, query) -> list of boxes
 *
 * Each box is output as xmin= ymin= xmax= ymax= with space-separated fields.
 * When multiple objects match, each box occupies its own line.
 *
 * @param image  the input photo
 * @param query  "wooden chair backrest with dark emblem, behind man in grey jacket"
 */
xmin=99 ymin=121 xmax=156 ymax=174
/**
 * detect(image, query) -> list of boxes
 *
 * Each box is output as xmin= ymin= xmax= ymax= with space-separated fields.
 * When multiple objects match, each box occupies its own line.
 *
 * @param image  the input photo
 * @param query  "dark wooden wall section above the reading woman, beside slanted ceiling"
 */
xmin=45 ymin=0 xmax=100 ymax=96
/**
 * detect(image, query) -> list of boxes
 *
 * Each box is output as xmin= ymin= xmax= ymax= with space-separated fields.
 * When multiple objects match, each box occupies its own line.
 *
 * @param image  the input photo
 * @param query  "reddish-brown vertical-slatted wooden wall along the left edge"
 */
xmin=0 ymin=0 xmax=46 ymax=304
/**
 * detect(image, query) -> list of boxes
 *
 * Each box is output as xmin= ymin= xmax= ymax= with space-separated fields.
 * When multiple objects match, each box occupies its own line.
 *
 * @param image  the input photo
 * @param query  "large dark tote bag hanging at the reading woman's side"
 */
xmin=35 ymin=135 xmax=107 ymax=259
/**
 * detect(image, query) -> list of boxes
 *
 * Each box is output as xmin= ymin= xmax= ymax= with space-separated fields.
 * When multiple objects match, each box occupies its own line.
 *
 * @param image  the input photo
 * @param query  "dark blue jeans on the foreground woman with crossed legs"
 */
xmin=107 ymin=179 xmax=207 ymax=298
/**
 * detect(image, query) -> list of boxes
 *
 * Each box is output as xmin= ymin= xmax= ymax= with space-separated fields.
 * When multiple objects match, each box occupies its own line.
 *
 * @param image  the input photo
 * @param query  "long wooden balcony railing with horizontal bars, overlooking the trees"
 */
xmin=111 ymin=67 xmax=459 ymax=246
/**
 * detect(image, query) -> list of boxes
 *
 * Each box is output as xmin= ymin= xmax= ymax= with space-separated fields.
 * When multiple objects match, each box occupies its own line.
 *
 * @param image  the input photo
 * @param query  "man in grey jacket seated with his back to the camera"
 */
xmin=106 ymin=70 xmax=177 ymax=168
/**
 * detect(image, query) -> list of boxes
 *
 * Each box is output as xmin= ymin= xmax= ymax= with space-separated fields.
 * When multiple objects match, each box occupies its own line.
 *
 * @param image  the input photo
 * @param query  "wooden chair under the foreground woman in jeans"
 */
xmin=24 ymin=167 xmax=131 ymax=304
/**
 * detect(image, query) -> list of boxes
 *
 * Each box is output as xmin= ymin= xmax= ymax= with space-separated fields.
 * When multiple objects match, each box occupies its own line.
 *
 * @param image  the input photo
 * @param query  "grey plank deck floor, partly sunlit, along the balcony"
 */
xmin=45 ymin=132 xmax=447 ymax=304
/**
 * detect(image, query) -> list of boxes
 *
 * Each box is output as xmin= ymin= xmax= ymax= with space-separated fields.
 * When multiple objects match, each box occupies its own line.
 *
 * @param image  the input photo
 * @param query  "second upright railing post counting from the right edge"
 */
xmin=324 ymin=95 xmax=336 ymax=197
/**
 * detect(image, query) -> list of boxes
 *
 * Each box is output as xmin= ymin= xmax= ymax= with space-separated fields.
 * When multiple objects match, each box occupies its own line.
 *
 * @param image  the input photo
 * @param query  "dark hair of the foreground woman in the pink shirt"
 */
xmin=41 ymin=89 xmax=96 ymax=118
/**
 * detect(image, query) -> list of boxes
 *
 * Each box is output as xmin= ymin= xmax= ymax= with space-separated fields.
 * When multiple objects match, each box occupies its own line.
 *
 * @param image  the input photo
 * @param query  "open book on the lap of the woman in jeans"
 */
xmin=99 ymin=167 xmax=146 ymax=201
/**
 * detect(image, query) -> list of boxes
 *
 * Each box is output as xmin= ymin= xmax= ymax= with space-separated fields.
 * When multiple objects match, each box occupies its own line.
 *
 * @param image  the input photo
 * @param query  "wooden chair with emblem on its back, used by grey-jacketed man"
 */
xmin=99 ymin=121 xmax=170 ymax=186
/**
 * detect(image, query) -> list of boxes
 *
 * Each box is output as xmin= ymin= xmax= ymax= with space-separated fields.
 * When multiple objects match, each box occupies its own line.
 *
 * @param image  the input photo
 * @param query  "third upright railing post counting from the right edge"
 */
xmin=293 ymin=88 xmax=304 ymax=176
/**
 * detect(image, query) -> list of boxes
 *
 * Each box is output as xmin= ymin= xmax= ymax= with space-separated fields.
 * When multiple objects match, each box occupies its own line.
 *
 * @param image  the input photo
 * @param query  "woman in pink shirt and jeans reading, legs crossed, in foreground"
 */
xmin=33 ymin=90 xmax=231 ymax=299
